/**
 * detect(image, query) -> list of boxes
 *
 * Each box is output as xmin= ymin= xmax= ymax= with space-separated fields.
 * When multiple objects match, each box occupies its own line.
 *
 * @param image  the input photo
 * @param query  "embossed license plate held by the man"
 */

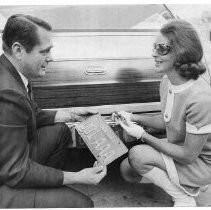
xmin=76 ymin=114 xmax=128 ymax=165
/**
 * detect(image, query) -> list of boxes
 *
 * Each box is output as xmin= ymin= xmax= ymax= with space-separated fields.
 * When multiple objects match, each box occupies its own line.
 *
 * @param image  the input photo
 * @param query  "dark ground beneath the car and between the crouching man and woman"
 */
xmin=67 ymin=149 xmax=211 ymax=208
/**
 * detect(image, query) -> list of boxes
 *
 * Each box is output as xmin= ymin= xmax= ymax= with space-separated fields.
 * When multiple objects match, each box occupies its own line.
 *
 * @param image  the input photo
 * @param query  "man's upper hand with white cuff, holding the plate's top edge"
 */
xmin=54 ymin=108 xmax=98 ymax=123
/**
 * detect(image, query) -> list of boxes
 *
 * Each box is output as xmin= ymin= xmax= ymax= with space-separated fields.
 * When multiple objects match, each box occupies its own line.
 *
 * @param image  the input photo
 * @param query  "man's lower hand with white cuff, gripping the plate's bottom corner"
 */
xmin=63 ymin=165 xmax=107 ymax=185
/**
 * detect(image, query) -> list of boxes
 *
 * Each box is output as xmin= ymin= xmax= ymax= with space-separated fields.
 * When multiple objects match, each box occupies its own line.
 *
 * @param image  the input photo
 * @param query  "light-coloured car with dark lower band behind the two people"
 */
xmin=0 ymin=4 xmax=210 ymax=148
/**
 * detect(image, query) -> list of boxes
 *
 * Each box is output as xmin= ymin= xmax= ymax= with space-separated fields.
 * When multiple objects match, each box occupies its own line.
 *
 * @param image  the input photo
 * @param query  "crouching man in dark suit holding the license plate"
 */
xmin=0 ymin=15 xmax=106 ymax=208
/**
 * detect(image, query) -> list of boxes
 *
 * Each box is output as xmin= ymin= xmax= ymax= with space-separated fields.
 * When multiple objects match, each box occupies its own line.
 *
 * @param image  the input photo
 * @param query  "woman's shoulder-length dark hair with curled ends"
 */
xmin=160 ymin=20 xmax=206 ymax=79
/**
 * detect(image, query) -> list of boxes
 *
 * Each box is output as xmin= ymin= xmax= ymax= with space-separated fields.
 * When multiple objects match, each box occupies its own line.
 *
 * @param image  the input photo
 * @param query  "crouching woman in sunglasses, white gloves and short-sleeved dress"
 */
xmin=113 ymin=20 xmax=211 ymax=206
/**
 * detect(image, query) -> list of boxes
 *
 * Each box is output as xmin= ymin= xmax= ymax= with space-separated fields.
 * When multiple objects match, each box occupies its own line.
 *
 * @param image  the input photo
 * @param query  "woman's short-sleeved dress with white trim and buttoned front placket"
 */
xmin=160 ymin=76 xmax=211 ymax=196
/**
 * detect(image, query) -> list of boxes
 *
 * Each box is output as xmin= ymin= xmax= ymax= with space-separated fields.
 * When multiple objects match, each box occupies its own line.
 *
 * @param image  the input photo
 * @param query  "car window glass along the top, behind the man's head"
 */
xmin=0 ymin=4 xmax=172 ymax=31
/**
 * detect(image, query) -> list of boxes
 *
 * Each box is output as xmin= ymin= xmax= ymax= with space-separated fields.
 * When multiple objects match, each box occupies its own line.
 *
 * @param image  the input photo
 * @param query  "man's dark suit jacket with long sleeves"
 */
xmin=0 ymin=54 xmax=63 ymax=200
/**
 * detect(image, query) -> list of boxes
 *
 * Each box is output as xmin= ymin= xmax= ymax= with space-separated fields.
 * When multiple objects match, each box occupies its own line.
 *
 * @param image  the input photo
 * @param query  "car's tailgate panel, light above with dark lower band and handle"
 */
xmin=33 ymin=32 xmax=162 ymax=108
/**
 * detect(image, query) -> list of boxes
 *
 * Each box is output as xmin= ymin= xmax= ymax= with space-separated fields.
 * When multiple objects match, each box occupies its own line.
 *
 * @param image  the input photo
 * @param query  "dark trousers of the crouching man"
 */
xmin=0 ymin=123 xmax=93 ymax=208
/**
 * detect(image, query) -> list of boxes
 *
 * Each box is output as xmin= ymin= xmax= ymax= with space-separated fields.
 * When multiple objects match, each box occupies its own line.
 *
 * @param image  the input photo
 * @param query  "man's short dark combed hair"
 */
xmin=2 ymin=14 xmax=52 ymax=54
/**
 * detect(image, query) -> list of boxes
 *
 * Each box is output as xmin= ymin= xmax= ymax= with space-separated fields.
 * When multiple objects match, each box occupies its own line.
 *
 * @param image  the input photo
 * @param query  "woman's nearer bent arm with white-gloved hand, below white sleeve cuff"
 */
xmin=117 ymin=116 xmax=208 ymax=164
